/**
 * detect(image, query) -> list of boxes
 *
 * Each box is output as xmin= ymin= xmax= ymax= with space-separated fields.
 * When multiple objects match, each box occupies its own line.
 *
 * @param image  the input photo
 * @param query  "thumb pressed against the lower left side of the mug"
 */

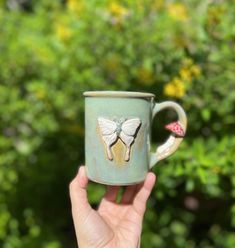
xmin=69 ymin=166 xmax=92 ymax=222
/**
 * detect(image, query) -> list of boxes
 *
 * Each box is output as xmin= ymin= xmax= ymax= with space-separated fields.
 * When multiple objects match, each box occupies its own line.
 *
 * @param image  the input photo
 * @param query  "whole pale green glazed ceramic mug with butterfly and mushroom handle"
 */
xmin=84 ymin=91 xmax=187 ymax=185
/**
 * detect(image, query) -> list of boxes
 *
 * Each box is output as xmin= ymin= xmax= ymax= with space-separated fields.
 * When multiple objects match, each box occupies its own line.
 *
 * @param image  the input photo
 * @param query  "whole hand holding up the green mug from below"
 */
xmin=69 ymin=166 xmax=156 ymax=248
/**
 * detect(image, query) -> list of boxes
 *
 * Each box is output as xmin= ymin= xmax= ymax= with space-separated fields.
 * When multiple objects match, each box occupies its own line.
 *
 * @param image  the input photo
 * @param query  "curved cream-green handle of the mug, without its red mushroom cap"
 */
xmin=150 ymin=101 xmax=187 ymax=168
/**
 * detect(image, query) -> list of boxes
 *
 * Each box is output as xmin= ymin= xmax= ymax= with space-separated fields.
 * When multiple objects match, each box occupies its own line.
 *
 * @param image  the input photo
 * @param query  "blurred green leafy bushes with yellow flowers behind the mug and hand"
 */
xmin=0 ymin=0 xmax=235 ymax=248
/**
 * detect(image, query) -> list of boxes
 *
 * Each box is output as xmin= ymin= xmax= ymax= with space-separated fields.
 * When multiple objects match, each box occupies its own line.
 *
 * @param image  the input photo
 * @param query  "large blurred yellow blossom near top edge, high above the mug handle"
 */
xmin=167 ymin=3 xmax=188 ymax=21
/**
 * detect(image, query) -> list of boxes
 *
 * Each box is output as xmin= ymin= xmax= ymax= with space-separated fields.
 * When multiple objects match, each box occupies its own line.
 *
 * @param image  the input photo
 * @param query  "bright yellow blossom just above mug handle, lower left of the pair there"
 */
xmin=164 ymin=77 xmax=185 ymax=98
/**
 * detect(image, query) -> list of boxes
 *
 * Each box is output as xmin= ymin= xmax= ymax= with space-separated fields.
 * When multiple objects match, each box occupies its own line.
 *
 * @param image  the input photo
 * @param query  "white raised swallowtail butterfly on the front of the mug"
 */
xmin=98 ymin=117 xmax=141 ymax=161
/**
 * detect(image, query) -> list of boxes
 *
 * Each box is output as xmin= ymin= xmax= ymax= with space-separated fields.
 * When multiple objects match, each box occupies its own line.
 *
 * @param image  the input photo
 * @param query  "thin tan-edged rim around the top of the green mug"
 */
xmin=83 ymin=90 xmax=155 ymax=98
